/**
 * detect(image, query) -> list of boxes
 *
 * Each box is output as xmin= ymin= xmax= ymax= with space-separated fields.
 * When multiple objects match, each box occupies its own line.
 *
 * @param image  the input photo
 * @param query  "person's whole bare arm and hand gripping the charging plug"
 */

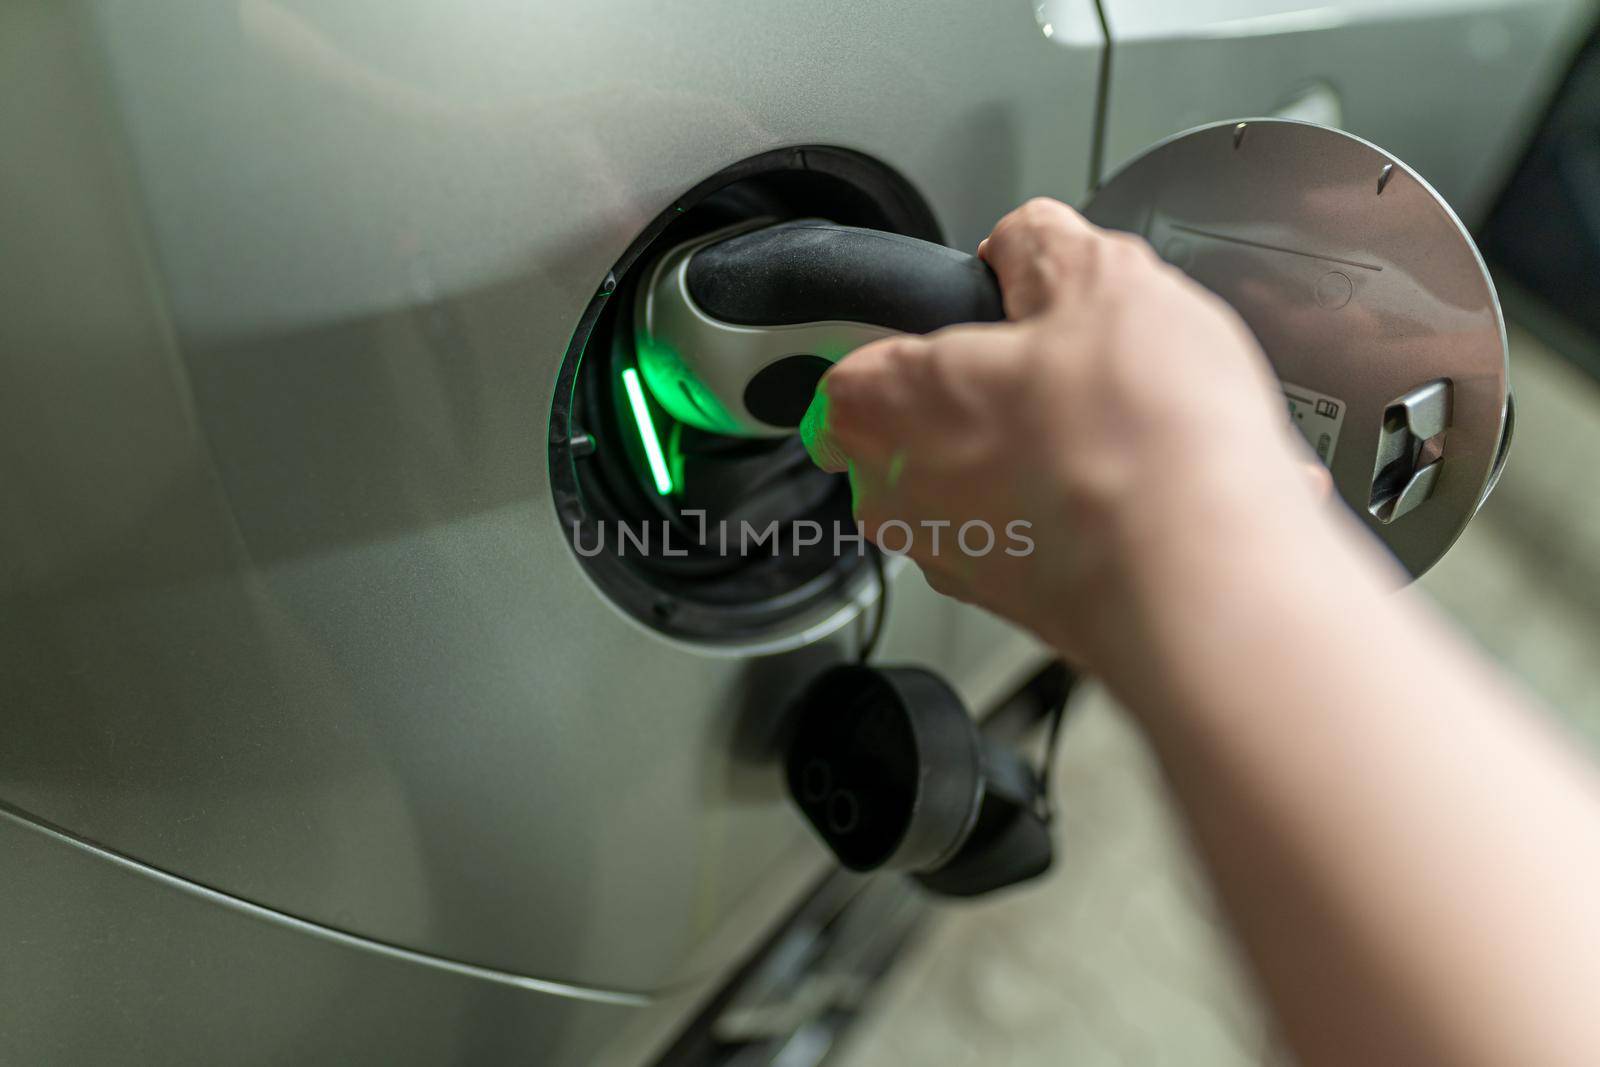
xmin=805 ymin=202 xmax=1600 ymax=1067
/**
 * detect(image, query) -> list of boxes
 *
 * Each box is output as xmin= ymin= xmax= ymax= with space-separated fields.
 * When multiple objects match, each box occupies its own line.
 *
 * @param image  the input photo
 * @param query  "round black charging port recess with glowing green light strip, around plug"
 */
xmin=550 ymin=147 xmax=939 ymax=645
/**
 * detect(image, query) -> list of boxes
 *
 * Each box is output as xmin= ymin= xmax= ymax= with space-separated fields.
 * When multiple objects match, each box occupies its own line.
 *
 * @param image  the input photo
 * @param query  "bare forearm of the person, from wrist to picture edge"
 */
xmin=1106 ymin=495 xmax=1600 ymax=1065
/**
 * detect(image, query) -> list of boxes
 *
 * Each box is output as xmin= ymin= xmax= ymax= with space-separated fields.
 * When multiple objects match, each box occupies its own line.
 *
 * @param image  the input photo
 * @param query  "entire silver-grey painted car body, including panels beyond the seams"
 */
xmin=0 ymin=0 xmax=1586 ymax=1064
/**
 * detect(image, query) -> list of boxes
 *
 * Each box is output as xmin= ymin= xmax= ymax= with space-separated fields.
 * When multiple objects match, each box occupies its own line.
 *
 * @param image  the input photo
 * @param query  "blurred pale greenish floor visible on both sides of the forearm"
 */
xmin=830 ymin=331 xmax=1600 ymax=1067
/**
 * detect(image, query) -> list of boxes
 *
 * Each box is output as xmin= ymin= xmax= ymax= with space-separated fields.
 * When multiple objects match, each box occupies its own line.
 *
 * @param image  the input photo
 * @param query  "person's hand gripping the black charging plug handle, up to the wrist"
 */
xmin=802 ymin=200 xmax=1330 ymax=665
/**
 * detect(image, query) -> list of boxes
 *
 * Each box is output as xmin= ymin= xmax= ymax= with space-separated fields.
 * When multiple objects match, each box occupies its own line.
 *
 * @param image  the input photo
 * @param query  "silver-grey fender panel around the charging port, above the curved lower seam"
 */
xmin=0 ymin=0 xmax=1098 ymax=990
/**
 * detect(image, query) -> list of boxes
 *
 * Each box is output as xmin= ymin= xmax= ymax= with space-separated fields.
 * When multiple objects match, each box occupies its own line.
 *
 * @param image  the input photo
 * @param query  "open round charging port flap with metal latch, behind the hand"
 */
xmin=1085 ymin=118 xmax=1510 ymax=574
